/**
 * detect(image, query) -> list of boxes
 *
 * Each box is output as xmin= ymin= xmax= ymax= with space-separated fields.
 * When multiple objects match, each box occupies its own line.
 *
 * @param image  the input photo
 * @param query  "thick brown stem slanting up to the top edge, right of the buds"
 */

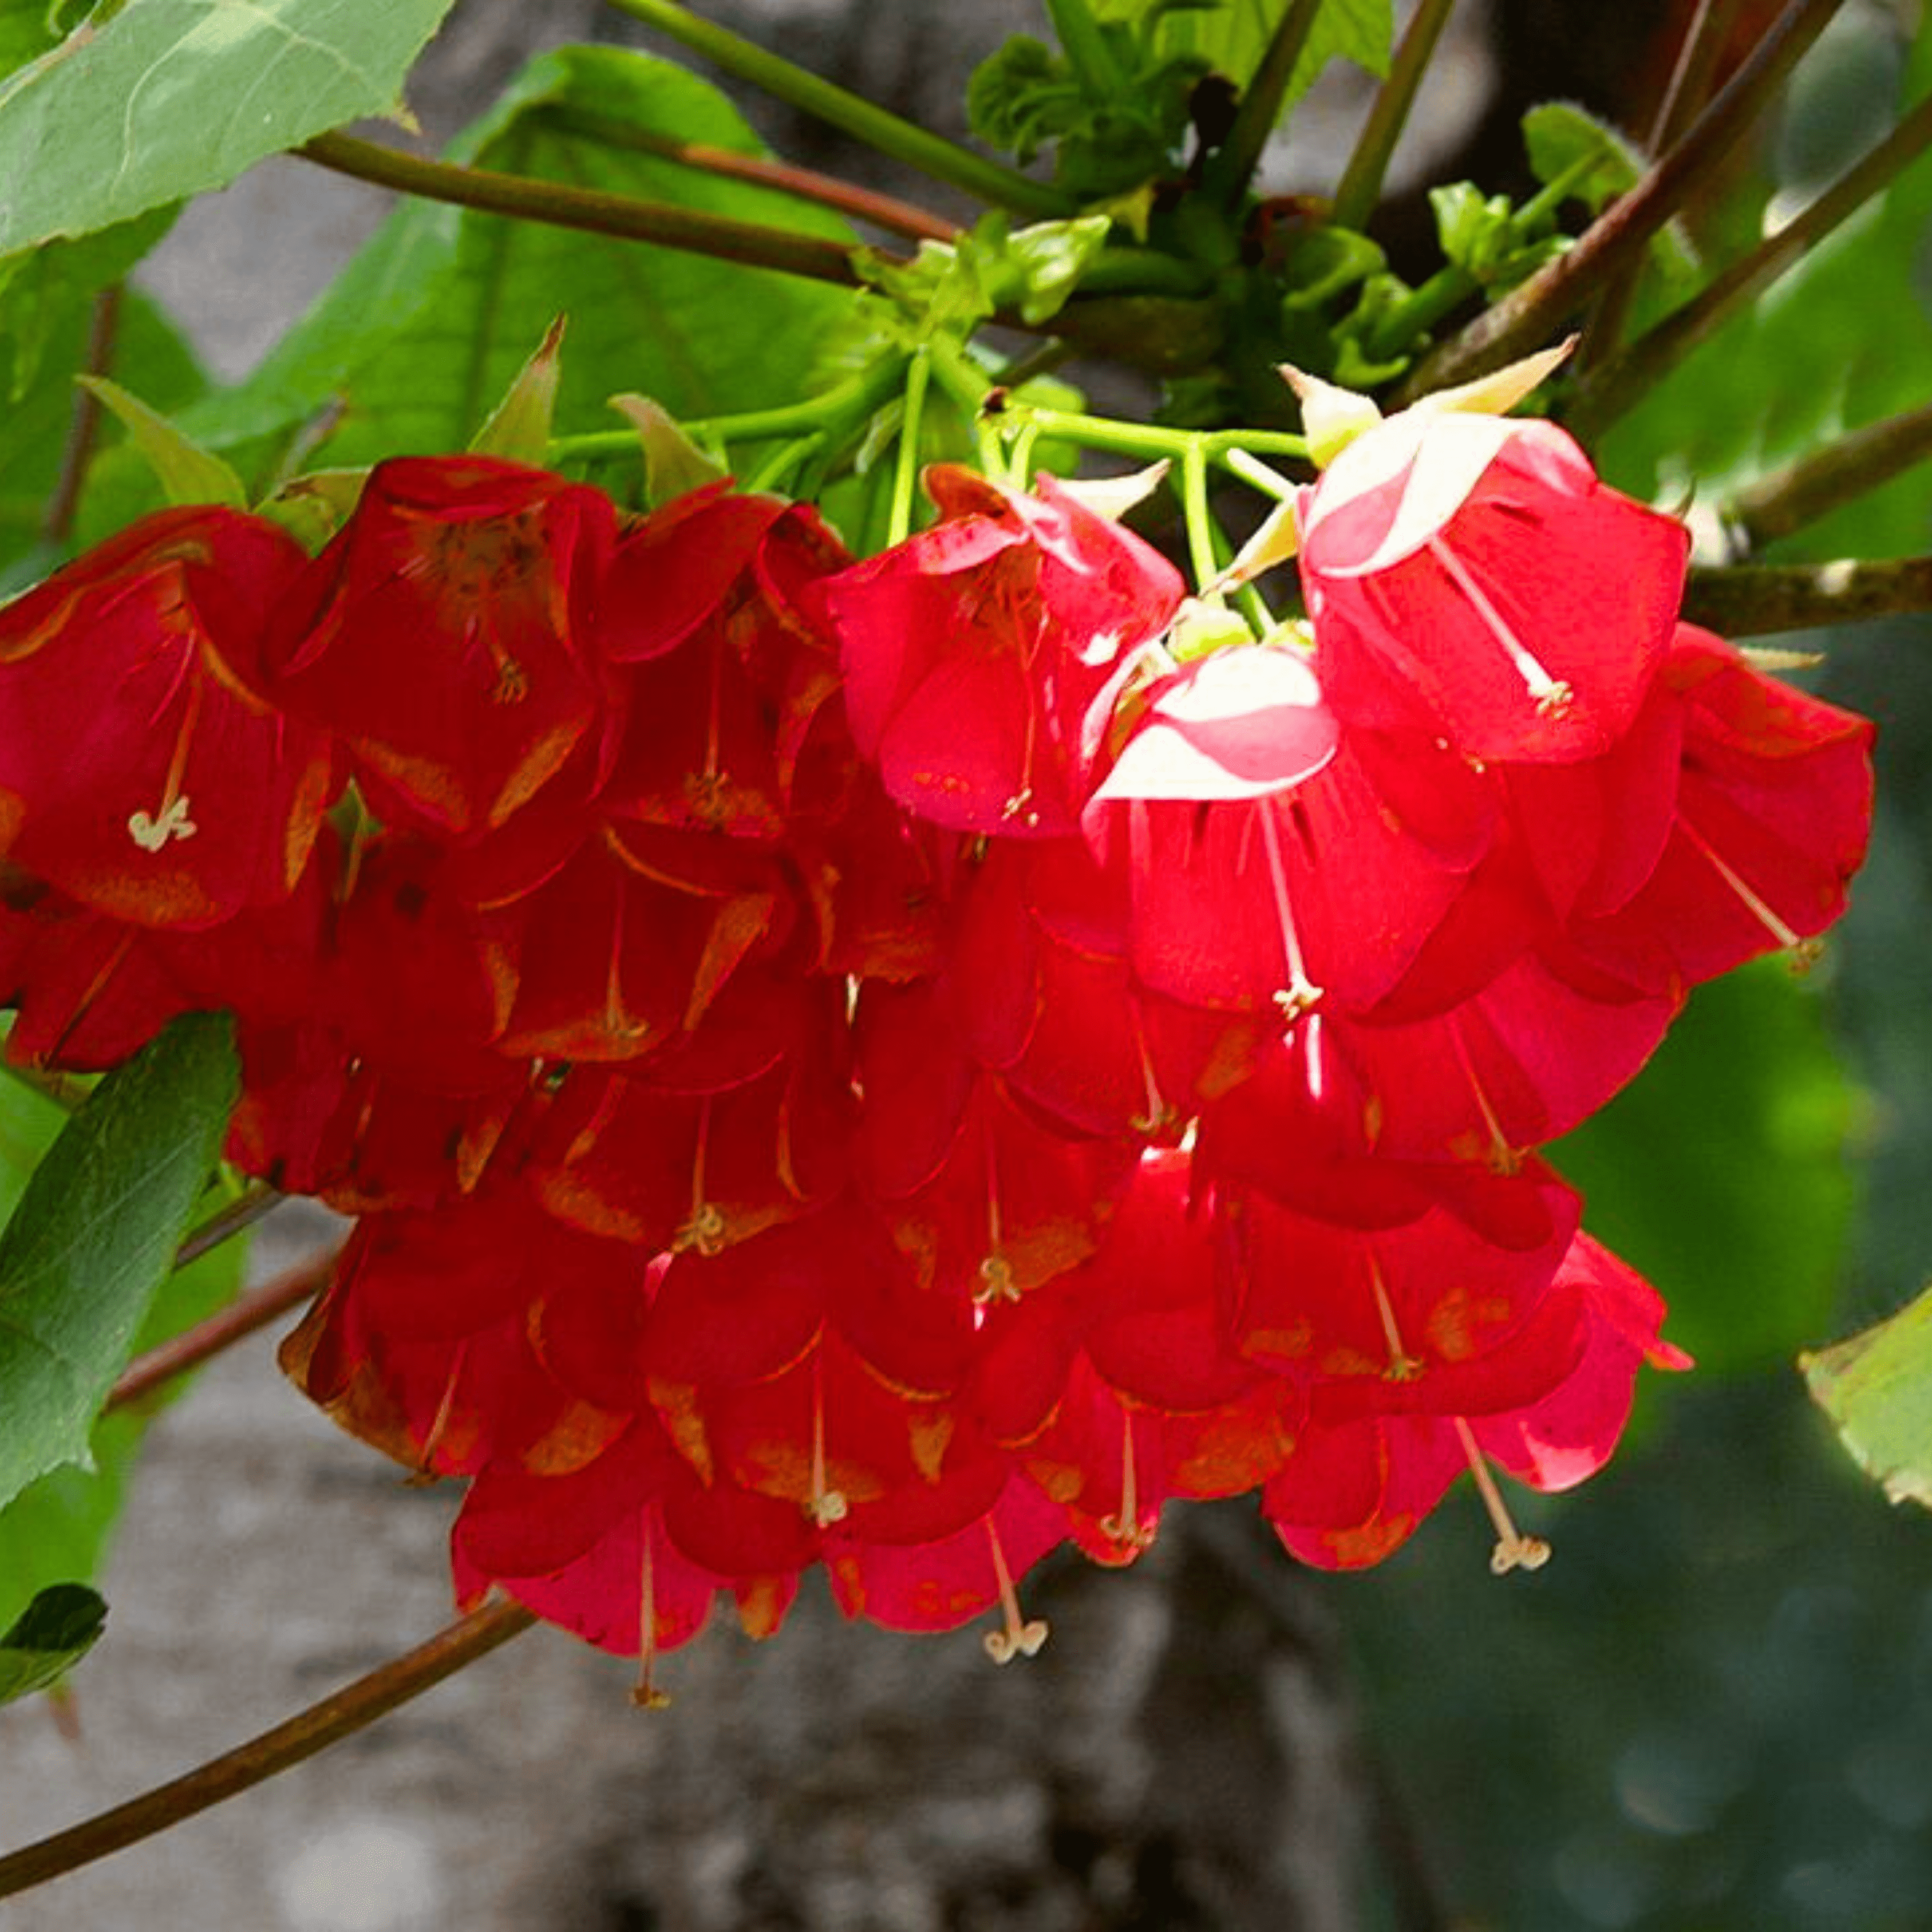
xmin=1399 ymin=0 xmax=1843 ymax=402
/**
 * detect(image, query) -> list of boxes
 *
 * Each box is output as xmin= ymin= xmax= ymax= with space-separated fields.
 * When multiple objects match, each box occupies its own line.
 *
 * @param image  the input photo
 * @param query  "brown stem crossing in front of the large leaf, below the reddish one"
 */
xmin=295 ymin=132 xmax=858 ymax=288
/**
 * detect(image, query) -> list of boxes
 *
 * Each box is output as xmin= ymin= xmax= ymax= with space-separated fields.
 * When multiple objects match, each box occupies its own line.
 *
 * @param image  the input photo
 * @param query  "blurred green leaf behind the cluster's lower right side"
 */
xmin=1551 ymin=960 xmax=1856 ymax=1370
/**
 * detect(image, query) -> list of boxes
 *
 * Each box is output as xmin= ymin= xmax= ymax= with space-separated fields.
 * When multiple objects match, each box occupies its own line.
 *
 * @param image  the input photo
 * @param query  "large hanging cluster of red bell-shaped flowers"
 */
xmin=0 ymin=377 xmax=1870 ymax=1694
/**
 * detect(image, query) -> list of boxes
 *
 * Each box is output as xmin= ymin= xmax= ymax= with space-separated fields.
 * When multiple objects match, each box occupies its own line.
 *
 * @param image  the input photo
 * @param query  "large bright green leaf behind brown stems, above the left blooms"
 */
xmin=187 ymin=46 xmax=852 ymax=464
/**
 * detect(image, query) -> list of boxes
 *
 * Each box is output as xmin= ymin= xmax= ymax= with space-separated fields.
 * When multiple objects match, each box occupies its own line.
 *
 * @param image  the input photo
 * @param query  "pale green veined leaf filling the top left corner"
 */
xmin=0 ymin=0 xmax=450 ymax=255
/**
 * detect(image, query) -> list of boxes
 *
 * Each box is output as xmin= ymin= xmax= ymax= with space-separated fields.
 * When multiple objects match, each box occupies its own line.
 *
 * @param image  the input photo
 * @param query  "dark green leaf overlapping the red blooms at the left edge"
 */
xmin=0 ymin=1014 xmax=238 ymax=1503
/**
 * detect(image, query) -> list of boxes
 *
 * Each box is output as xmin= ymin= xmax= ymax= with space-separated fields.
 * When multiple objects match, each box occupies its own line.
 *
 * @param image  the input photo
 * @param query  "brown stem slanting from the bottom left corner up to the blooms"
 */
xmin=0 ymin=1602 xmax=537 ymax=1899
